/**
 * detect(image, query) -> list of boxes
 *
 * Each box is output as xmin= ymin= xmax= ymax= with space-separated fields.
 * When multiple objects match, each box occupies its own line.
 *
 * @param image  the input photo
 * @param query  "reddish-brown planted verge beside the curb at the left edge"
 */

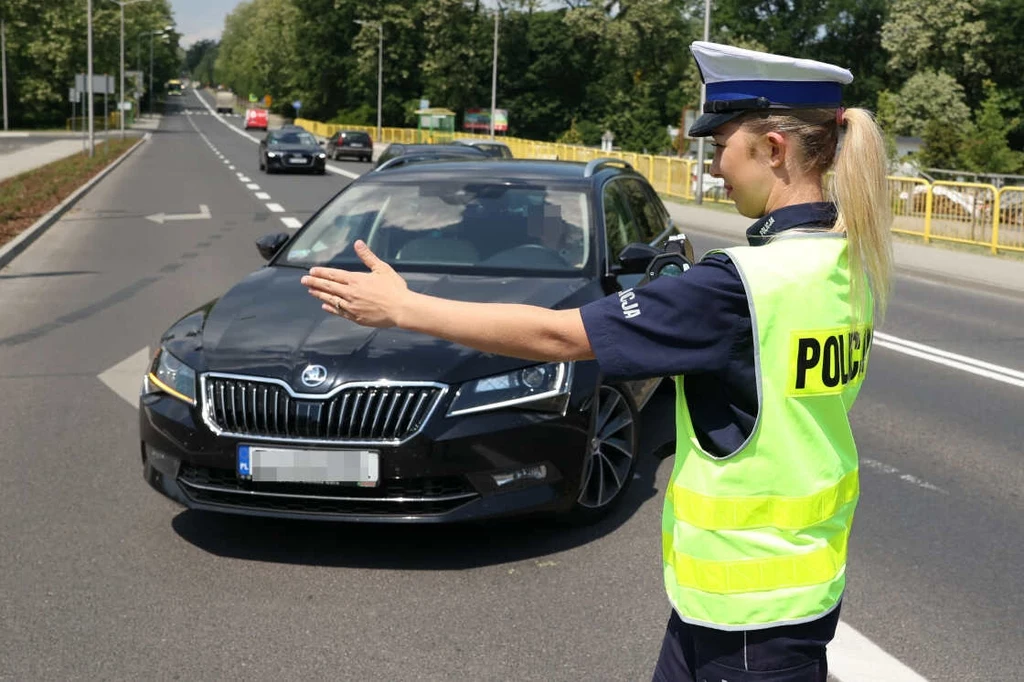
xmin=0 ymin=137 xmax=138 ymax=246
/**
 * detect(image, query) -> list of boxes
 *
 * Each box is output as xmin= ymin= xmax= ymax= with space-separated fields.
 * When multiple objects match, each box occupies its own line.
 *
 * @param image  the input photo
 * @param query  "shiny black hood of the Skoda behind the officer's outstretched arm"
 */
xmin=163 ymin=266 xmax=599 ymax=393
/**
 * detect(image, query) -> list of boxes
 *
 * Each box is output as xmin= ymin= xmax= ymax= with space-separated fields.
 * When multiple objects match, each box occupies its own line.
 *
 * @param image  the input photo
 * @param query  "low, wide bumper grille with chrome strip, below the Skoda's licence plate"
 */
xmin=178 ymin=464 xmax=479 ymax=516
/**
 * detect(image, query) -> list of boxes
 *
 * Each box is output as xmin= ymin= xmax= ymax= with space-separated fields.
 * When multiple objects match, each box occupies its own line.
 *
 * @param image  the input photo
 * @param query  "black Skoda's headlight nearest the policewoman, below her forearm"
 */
xmin=447 ymin=363 xmax=572 ymax=417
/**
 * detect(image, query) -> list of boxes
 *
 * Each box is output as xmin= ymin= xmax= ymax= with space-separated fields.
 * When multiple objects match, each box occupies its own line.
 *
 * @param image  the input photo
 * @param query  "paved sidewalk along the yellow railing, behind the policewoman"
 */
xmin=665 ymin=196 xmax=1024 ymax=293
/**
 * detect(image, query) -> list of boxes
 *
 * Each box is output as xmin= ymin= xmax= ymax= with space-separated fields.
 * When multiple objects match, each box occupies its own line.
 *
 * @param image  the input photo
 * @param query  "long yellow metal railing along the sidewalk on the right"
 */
xmin=295 ymin=119 xmax=1024 ymax=254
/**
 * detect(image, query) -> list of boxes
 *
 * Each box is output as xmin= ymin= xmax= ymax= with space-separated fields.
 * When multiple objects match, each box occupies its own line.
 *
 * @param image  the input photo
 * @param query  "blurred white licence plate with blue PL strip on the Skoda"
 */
xmin=236 ymin=445 xmax=380 ymax=487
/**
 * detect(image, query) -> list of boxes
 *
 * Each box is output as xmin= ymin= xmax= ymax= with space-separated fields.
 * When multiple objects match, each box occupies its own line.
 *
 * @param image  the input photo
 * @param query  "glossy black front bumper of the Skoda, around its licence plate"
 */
xmin=139 ymin=382 xmax=590 ymax=523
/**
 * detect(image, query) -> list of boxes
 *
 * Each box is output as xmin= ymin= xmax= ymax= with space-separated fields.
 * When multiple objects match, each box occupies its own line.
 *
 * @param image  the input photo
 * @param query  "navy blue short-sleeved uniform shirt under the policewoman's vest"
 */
xmin=580 ymin=203 xmax=836 ymax=457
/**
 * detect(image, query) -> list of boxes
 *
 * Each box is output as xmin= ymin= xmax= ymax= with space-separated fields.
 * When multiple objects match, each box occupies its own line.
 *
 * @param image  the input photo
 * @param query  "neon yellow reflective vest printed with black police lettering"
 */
xmin=662 ymin=233 xmax=872 ymax=630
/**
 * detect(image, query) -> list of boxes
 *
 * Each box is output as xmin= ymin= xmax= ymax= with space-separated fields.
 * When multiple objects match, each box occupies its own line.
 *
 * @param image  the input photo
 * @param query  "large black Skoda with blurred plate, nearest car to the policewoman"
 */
xmin=138 ymin=159 xmax=672 ymax=522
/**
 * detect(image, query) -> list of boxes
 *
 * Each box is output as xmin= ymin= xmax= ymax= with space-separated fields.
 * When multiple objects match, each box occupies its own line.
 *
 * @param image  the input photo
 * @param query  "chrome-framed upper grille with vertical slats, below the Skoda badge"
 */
xmin=203 ymin=375 xmax=444 ymax=444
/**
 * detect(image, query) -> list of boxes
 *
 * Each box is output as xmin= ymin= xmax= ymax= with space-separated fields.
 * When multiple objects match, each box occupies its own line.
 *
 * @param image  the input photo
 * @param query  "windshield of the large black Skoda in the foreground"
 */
xmin=276 ymin=178 xmax=594 ymax=274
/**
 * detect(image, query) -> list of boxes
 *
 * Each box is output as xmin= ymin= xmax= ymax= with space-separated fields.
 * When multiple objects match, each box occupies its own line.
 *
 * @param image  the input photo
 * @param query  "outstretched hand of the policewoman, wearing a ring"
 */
xmin=302 ymin=240 xmax=410 ymax=327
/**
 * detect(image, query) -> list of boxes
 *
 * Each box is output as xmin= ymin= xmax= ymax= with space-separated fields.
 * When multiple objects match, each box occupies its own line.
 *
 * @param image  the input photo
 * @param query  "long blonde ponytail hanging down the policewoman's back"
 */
xmin=829 ymin=109 xmax=893 ymax=319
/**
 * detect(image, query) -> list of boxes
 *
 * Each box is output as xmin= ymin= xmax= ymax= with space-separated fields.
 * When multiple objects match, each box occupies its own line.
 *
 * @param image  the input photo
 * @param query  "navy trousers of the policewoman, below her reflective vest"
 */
xmin=653 ymin=606 xmax=839 ymax=682
